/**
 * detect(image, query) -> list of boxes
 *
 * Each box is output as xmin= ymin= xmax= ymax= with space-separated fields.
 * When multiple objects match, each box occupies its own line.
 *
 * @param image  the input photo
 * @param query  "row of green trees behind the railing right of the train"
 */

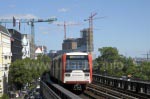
xmin=93 ymin=47 xmax=150 ymax=80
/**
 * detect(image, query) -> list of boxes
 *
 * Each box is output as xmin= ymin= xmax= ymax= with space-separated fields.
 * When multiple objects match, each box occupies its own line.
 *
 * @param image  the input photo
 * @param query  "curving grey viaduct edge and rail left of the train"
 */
xmin=40 ymin=74 xmax=82 ymax=99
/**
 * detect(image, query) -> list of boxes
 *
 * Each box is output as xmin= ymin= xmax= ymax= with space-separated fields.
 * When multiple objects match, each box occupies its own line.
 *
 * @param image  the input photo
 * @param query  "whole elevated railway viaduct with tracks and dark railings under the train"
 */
xmin=41 ymin=74 xmax=150 ymax=99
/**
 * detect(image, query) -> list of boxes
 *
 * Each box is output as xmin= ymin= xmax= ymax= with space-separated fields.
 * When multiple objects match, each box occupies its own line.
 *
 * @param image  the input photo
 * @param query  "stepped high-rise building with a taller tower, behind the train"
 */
xmin=62 ymin=28 xmax=94 ymax=52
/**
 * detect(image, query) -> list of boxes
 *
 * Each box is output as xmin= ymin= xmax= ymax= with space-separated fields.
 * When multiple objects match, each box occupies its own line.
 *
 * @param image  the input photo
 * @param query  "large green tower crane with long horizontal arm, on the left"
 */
xmin=0 ymin=16 xmax=57 ymax=58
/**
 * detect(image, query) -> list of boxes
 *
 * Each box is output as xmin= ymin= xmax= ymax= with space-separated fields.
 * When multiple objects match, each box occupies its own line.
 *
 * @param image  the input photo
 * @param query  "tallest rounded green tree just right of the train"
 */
xmin=95 ymin=47 xmax=119 ymax=74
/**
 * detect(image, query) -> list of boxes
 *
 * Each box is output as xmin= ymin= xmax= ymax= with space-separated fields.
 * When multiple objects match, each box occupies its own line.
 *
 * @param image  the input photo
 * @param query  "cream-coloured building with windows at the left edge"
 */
xmin=0 ymin=25 xmax=12 ymax=96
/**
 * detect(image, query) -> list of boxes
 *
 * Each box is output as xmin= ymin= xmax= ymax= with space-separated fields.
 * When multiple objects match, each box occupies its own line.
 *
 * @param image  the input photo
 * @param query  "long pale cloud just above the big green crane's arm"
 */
xmin=0 ymin=14 xmax=38 ymax=19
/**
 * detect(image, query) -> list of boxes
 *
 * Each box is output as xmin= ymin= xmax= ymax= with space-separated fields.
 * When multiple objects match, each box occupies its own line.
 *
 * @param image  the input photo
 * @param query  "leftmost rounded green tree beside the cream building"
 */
xmin=9 ymin=60 xmax=32 ymax=89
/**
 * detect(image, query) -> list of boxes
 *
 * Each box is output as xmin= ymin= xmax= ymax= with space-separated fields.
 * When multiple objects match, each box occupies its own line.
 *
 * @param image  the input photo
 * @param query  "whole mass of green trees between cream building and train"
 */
xmin=9 ymin=55 xmax=50 ymax=89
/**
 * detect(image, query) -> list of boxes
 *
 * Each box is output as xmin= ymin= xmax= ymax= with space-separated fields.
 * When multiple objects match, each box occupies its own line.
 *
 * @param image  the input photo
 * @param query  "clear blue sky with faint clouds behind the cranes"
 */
xmin=0 ymin=0 xmax=150 ymax=58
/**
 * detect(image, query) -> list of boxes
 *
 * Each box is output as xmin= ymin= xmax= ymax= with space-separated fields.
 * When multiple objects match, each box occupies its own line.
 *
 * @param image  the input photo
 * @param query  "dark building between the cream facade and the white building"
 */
xmin=8 ymin=29 xmax=22 ymax=62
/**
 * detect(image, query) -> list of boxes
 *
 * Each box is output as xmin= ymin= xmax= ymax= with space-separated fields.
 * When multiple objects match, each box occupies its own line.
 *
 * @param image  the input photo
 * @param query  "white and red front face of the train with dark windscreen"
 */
xmin=64 ymin=53 xmax=92 ymax=90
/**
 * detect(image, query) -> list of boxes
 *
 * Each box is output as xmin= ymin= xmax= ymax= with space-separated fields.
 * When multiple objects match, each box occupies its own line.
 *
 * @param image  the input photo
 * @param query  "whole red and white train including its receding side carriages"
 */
xmin=50 ymin=52 xmax=92 ymax=90
